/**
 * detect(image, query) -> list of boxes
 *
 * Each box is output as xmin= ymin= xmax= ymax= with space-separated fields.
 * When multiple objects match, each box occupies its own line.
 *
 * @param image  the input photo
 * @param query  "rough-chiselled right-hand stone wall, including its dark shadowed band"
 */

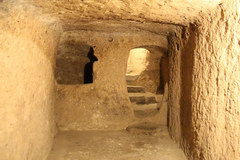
xmin=169 ymin=1 xmax=240 ymax=160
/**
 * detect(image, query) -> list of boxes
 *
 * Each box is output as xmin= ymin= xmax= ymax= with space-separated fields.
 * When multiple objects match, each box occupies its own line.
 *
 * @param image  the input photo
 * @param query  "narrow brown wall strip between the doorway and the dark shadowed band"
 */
xmin=168 ymin=28 xmax=184 ymax=142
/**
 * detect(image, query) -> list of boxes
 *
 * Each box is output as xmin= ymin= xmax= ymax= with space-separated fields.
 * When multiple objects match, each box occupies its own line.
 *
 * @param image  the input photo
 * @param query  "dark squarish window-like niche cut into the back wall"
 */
xmin=55 ymin=42 xmax=98 ymax=85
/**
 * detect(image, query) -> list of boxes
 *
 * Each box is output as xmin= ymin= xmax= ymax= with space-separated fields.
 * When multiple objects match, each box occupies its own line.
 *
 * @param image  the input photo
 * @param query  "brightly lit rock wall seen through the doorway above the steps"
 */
xmin=127 ymin=44 xmax=168 ymax=93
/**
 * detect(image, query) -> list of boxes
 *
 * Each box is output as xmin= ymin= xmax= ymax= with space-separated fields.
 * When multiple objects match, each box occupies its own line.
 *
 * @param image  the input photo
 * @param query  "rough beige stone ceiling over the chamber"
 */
xmin=26 ymin=0 xmax=221 ymax=25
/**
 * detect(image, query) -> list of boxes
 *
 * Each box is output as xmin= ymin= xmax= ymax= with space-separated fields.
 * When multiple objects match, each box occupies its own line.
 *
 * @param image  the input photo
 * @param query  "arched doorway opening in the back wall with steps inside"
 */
xmin=126 ymin=46 xmax=168 ymax=124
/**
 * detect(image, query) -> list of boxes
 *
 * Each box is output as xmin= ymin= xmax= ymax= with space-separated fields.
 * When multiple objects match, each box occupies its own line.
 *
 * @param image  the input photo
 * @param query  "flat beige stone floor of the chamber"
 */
xmin=48 ymin=127 xmax=186 ymax=160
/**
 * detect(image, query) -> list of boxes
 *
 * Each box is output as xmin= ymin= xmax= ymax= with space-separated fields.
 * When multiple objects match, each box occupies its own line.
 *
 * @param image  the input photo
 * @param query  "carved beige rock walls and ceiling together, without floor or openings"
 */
xmin=0 ymin=0 xmax=240 ymax=160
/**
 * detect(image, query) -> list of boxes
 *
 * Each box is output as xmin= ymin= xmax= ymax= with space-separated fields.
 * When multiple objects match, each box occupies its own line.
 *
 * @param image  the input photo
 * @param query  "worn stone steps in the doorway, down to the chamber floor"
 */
xmin=126 ymin=75 xmax=167 ymax=135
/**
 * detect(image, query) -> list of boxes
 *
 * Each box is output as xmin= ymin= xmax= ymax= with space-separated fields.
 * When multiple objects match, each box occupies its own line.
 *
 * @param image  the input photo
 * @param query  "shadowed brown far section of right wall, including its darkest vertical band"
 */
xmin=168 ymin=24 xmax=198 ymax=156
